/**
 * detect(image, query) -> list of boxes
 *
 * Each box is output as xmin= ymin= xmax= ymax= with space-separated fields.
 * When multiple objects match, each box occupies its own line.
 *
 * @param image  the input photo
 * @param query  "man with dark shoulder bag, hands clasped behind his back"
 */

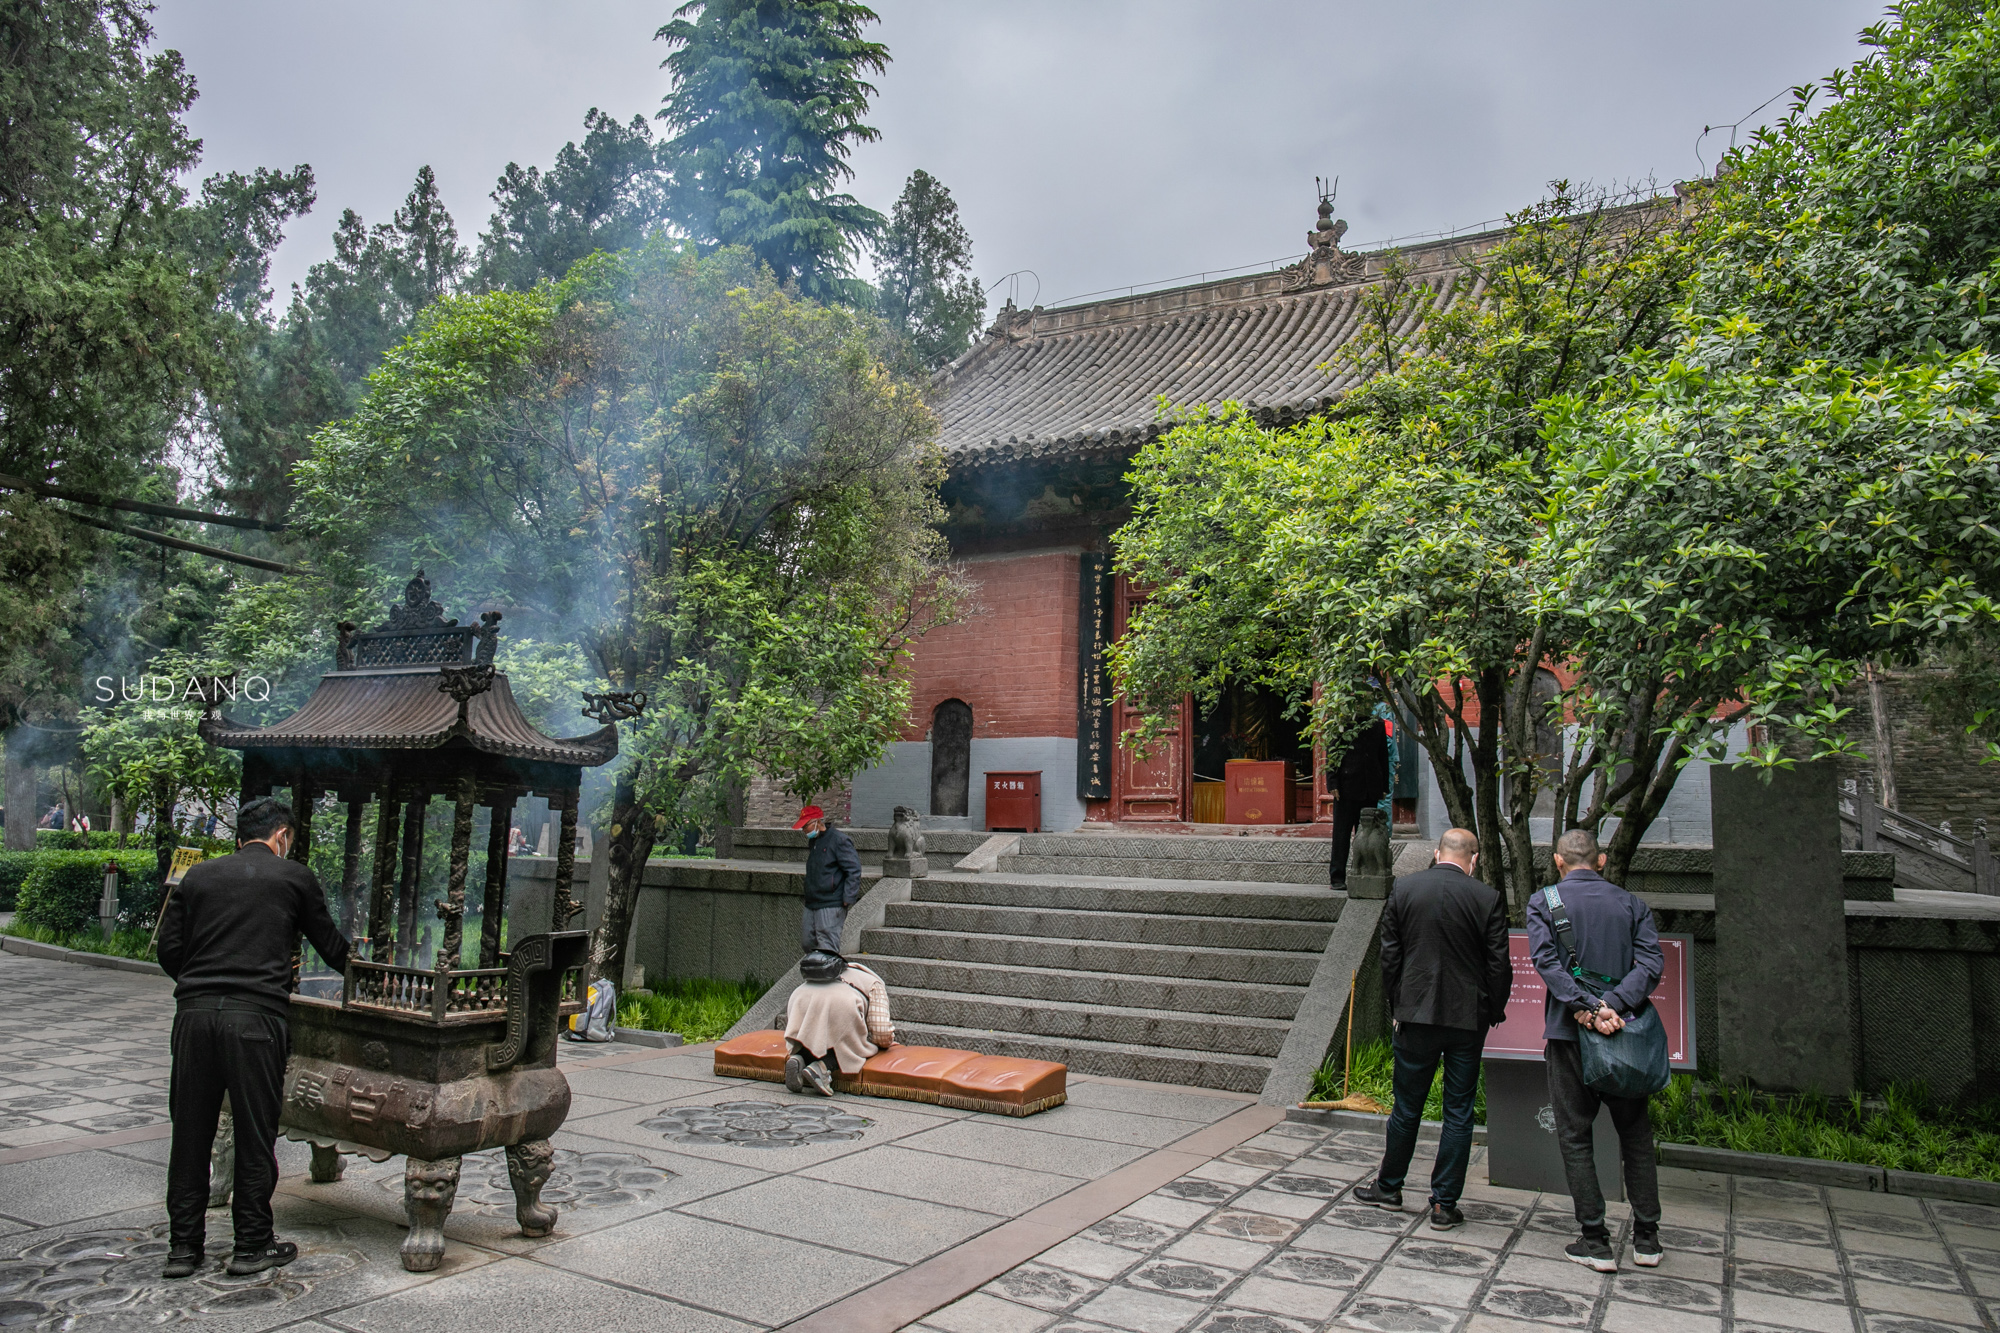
xmin=1528 ymin=829 xmax=1664 ymax=1273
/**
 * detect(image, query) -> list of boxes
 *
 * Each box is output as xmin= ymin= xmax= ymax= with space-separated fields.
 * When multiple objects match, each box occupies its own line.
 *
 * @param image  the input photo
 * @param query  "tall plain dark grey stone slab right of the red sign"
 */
xmin=1710 ymin=763 xmax=1854 ymax=1097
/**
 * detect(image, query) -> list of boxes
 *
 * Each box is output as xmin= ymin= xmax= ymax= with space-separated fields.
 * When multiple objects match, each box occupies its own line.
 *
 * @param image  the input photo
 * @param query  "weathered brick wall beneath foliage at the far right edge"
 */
xmin=1840 ymin=671 xmax=2000 ymax=839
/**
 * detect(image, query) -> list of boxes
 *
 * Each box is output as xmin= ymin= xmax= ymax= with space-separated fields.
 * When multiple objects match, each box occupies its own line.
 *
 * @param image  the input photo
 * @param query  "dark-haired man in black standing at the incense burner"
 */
xmin=160 ymin=797 xmax=348 ymax=1277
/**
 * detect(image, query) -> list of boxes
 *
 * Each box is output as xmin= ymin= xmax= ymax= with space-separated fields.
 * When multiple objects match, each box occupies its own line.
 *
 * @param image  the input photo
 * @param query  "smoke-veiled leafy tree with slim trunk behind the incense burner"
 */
xmin=300 ymin=236 xmax=954 ymax=975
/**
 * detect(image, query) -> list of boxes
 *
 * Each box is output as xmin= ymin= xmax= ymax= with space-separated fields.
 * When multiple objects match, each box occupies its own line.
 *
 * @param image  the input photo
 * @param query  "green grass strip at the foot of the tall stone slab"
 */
xmin=1652 ymin=1075 xmax=2000 ymax=1181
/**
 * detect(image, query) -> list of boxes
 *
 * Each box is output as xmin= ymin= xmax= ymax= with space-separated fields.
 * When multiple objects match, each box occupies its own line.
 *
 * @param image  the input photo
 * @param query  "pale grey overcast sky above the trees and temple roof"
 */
xmin=154 ymin=0 xmax=1884 ymax=314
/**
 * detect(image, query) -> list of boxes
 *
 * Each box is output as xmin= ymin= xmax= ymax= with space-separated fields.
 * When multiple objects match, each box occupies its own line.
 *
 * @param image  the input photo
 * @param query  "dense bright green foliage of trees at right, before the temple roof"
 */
xmin=1114 ymin=0 xmax=2000 ymax=892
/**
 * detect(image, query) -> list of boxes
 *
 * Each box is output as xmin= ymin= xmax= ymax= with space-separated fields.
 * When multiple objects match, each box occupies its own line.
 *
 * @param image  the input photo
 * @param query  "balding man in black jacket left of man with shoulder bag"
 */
xmin=1354 ymin=829 xmax=1514 ymax=1231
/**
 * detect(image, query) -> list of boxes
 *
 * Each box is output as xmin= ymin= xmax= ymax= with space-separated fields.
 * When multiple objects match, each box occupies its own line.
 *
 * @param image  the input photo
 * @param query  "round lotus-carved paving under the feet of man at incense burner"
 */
xmin=0 ymin=1221 xmax=366 ymax=1333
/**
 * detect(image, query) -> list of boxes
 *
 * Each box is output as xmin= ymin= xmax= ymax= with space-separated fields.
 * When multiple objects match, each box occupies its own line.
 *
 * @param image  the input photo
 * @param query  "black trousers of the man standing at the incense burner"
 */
xmin=166 ymin=999 xmax=292 ymax=1253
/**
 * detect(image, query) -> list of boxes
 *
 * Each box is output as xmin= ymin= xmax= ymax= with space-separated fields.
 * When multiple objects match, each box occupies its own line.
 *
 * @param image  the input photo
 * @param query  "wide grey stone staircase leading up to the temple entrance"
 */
xmin=862 ymin=833 xmax=1346 ymax=1093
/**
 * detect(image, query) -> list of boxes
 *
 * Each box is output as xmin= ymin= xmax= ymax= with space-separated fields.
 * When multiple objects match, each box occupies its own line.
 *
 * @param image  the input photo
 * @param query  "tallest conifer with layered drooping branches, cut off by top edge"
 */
xmin=656 ymin=0 xmax=888 ymax=304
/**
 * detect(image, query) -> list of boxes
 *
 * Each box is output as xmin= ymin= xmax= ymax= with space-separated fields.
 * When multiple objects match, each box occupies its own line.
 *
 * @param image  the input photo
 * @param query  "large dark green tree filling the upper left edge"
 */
xmin=0 ymin=0 xmax=312 ymax=840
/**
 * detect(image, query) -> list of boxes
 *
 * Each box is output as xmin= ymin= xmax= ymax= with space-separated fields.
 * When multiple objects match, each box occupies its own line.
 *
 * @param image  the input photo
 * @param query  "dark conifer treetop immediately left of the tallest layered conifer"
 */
xmin=474 ymin=106 xmax=668 ymax=292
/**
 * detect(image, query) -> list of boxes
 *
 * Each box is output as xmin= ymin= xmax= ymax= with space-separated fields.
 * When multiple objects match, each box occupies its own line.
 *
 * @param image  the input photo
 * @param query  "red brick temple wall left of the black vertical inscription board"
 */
xmin=904 ymin=552 xmax=1078 ymax=741
